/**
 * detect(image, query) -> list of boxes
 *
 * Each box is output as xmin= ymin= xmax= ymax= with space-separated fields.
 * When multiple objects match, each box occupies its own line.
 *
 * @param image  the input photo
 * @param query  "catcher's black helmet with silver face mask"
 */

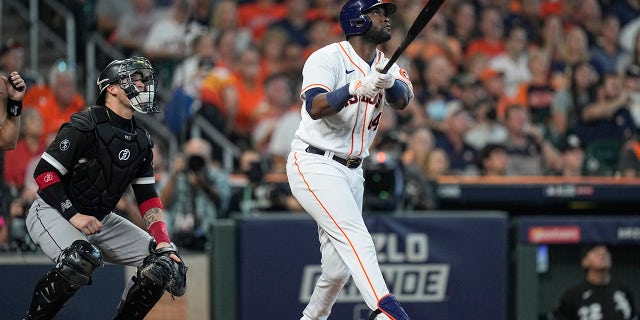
xmin=96 ymin=57 xmax=159 ymax=113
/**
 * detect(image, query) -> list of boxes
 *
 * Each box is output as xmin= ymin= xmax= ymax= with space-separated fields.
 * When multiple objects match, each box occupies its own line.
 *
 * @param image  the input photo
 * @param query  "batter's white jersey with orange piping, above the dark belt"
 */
xmin=292 ymin=41 xmax=413 ymax=158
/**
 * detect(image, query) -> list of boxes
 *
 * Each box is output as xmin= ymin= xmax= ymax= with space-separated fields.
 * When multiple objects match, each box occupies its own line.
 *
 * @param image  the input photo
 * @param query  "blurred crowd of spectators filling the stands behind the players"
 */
xmin=0 ymin=0 xmax=640 ymax=250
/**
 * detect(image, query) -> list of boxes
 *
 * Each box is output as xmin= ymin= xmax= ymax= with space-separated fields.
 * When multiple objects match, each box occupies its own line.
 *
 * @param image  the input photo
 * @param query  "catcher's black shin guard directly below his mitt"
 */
xmin=113 ymin=276 xmax=164 ymax=320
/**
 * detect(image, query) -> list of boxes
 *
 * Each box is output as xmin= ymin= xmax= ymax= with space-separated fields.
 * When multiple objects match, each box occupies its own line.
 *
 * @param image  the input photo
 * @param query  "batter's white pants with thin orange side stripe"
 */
xmin=287 ymin=151 xmax=389 ymax=320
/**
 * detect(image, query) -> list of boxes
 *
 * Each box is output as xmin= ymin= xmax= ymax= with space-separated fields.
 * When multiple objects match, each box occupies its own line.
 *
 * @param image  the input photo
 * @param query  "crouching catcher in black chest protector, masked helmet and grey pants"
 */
xmin=26 ymin=57 xmax=187 ymax=320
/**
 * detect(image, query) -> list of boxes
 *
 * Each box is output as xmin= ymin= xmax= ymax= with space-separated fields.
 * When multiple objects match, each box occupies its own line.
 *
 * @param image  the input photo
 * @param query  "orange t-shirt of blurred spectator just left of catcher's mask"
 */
xmin=23 ymin=86 xmax=86 ymax=139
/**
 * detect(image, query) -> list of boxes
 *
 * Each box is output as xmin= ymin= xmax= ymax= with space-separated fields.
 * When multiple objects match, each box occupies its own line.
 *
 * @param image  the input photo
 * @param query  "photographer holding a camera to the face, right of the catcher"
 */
xmin=160 ymin=138 xmax=231 ymax=250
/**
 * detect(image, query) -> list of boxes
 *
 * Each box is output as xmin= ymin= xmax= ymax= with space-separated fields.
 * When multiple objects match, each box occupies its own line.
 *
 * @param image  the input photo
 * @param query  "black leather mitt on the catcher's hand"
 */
xmin=138 ymin=245 xmax=189 ymax=298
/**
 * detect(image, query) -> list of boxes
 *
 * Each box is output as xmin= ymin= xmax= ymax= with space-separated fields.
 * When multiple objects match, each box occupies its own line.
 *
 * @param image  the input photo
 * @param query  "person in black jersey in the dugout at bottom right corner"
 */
xmin=552 ymin=244 xmax=638 ymax=320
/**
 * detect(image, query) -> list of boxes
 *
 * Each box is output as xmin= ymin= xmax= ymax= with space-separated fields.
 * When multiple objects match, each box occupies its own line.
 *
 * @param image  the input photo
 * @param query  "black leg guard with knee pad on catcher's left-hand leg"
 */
xmin=27 ymin=240 xmax=103 ymax=319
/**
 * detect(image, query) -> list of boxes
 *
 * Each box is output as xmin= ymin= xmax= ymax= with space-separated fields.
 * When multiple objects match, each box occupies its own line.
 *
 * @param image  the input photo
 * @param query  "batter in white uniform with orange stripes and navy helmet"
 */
xmin=287 ymin=0 xmax=413 ymax=320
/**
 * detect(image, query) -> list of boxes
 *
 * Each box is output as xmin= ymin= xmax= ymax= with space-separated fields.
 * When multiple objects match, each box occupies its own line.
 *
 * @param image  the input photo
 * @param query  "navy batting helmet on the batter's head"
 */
xmin=340 ymin=0 xmax=396 ymax=36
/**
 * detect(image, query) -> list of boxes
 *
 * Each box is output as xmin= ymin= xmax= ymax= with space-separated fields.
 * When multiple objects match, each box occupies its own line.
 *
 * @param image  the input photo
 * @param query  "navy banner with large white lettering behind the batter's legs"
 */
xmin=238 ymin=213 xmax=508 ymax=320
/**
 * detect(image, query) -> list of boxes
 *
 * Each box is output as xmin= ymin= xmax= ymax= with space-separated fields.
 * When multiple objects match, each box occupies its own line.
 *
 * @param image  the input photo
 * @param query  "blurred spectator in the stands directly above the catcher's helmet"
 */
xmin=114 ymin=0 xmax=166 ymax=56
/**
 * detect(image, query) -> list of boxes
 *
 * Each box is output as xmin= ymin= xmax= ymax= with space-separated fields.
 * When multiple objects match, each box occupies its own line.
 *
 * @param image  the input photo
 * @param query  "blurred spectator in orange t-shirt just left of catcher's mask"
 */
xmin=24 ymin=60 xmax=86 ymax=139
